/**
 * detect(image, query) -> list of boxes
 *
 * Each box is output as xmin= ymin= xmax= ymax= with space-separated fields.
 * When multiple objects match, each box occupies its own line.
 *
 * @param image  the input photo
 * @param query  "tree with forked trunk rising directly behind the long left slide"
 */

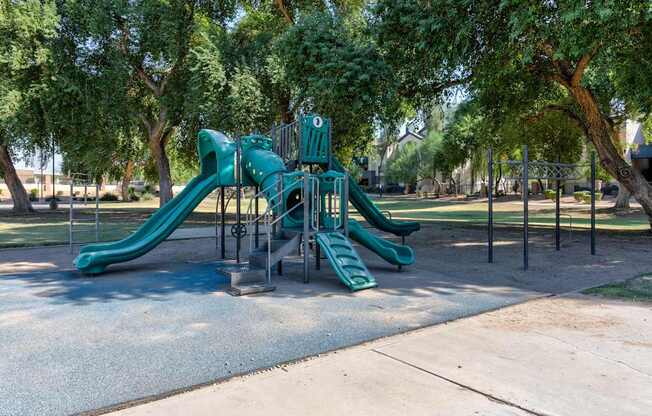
xmin=59 ymin=0 xmax=235 ymax=205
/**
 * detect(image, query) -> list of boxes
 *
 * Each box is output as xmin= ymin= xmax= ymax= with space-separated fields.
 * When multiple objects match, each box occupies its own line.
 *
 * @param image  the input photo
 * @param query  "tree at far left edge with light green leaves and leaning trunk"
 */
xmin=0 ymin=0 xmax=59 ymax=212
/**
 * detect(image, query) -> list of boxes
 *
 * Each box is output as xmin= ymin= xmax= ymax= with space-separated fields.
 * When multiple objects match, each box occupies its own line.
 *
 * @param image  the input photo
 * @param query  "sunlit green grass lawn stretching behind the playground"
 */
xmin=0 ymin=191 xmax=649 ymax=248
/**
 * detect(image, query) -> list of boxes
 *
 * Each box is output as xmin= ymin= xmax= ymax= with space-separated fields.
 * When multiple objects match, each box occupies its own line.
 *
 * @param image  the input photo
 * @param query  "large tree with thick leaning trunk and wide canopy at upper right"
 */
xmin=374 ymin=0 xmax=652 ymax=225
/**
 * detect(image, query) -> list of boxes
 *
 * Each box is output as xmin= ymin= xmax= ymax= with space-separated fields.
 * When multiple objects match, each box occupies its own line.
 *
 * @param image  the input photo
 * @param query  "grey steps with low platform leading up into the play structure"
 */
xmin=218 ymin=231 xmax=301 ymax=296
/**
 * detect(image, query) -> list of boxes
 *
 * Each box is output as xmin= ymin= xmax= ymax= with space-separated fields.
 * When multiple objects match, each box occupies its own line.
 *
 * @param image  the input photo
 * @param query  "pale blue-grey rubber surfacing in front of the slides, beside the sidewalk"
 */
xmin=0 ymin=262 xmax=533 ymax=415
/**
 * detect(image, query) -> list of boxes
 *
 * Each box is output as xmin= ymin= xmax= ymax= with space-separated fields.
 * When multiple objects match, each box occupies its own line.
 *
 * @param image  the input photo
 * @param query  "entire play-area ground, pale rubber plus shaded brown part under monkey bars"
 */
xmin=0 ymin=225 xmax=650 ymax=415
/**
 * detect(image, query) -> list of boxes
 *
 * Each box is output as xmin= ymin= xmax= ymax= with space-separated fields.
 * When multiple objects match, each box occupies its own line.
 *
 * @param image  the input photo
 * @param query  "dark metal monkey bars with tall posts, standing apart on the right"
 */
xmin=487 ymin=145 xmax=596 ymax=270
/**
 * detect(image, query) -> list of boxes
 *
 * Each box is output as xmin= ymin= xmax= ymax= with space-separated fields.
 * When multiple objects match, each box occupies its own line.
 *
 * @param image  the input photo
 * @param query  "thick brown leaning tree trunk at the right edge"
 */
xmin=569 ymin=85 xmax=652 ymax=228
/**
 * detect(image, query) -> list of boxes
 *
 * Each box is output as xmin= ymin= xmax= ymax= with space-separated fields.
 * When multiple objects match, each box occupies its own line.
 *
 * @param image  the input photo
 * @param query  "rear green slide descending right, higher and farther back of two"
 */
xmin=332 ymin=157 xmax=421 ymax=236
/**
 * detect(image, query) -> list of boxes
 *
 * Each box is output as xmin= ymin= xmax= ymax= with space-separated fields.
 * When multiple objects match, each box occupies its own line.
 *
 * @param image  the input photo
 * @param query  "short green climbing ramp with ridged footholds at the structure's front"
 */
xmin=315 ymin=231 xmax=378 ymax=290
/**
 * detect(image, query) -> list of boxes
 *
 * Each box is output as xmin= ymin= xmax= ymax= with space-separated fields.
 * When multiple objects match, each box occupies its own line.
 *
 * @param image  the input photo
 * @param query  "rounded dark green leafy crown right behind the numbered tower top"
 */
xmin=278 ymin=12 xmax=399 ymax=158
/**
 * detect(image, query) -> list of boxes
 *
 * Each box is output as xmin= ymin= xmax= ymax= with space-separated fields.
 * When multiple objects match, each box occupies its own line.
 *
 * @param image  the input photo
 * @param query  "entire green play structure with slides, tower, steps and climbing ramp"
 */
xmin=75 ymin=115 xmax=419 ymax=295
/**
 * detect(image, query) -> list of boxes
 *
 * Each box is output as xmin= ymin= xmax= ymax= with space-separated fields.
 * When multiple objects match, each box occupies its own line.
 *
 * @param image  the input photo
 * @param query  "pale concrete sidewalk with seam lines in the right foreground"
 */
xmin=114 ymin=296 xmax=652 ymax=416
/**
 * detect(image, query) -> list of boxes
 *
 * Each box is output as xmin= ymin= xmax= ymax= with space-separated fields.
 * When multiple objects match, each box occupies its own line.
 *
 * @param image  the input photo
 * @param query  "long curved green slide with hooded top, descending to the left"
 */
xmin=74 ymin=130 xmax=235 ymax=274
